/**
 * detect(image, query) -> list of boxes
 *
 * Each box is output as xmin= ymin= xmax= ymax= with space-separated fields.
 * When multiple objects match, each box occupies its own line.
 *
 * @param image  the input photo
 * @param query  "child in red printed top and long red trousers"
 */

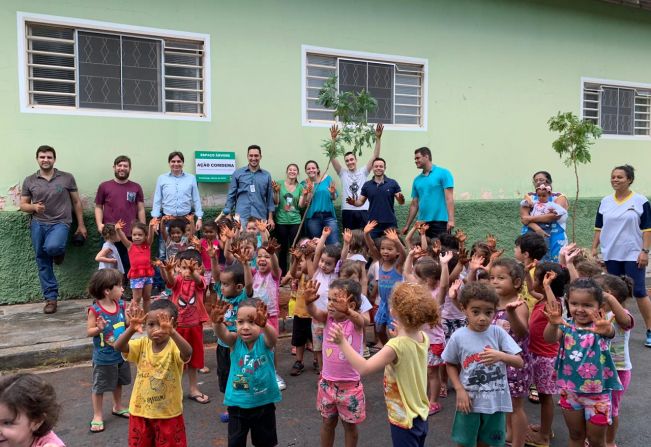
xmin=160 ymin=250 xmax=210 ymax=404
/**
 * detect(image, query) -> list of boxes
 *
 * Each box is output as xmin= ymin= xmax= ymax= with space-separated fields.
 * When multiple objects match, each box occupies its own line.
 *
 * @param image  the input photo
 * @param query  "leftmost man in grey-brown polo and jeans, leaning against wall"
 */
xmin=20 ymin=146 xmax=88 ymax=314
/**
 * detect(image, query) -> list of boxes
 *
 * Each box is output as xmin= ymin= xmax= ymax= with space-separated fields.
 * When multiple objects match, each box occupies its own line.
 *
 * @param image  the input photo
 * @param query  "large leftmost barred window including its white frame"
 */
xmin=19 ymin=13 xmax=209 ymax=119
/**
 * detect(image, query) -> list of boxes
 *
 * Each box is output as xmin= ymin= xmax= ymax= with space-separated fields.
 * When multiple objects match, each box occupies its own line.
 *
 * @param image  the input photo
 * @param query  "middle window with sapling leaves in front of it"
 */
xmin=303 ymin=46 xmax=427 ymax=130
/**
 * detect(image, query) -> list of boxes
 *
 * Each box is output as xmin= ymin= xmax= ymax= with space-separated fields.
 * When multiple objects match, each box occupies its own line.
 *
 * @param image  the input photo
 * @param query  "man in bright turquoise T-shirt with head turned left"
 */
xmin=402 ymin=147 xmax=454 ymax=237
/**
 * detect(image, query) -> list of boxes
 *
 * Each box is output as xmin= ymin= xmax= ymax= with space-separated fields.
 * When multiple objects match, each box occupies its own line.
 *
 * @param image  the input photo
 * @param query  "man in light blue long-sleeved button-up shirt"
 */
xmin=151 ymin=152 xmax=203 ymax=231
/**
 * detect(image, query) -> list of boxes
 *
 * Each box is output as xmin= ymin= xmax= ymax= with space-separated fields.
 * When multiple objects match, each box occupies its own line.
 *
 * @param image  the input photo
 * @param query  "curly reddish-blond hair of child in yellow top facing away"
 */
xmin=391 ymin=282 xmax=441 ymax=329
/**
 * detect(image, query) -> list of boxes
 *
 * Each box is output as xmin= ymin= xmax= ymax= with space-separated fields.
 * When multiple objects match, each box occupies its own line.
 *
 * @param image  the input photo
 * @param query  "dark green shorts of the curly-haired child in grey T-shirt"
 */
xmin=452 ymin=411 xmax=506 ymax=447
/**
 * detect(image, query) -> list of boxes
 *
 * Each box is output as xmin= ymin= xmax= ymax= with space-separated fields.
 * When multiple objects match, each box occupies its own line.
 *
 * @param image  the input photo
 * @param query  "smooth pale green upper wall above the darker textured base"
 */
xmin=0 ymin=0 xmax=651 ymax=209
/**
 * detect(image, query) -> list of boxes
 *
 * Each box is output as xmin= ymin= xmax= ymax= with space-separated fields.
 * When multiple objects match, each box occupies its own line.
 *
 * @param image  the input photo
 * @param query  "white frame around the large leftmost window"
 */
xmin=16 ymin=11 xmax=211 ymax=121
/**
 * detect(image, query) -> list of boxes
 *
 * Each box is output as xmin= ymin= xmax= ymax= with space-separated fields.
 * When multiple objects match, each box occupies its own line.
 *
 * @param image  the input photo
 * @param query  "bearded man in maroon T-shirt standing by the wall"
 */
xmin=95 ymin=155 xmax=145 ymax=277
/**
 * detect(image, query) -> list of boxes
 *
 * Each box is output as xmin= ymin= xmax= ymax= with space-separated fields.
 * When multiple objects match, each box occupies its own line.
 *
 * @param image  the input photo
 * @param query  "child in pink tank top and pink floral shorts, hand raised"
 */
xmin=305 ymin=279 xmax=366 ymax=447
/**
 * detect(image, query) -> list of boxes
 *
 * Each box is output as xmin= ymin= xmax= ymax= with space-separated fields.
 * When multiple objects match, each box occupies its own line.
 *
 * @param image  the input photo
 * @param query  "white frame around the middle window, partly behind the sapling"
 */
xmin=301 ymin=45 xmax=428 ymax=132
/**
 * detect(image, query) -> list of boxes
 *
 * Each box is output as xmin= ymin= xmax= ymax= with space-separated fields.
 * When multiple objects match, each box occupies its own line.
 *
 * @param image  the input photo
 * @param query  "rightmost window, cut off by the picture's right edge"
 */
xmin=582 ymin=80 xmax=651 ymax=137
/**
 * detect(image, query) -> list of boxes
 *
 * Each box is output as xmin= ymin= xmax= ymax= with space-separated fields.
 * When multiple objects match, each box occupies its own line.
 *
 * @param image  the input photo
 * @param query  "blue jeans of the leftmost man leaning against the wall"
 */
xmin=30 ymin=219 xmax=70 ymax=300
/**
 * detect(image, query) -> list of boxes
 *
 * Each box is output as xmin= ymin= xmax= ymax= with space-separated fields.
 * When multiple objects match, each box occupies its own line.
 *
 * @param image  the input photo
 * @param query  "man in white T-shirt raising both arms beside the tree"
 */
xmin=330 ymin=124 xmax=384 ymax=230
